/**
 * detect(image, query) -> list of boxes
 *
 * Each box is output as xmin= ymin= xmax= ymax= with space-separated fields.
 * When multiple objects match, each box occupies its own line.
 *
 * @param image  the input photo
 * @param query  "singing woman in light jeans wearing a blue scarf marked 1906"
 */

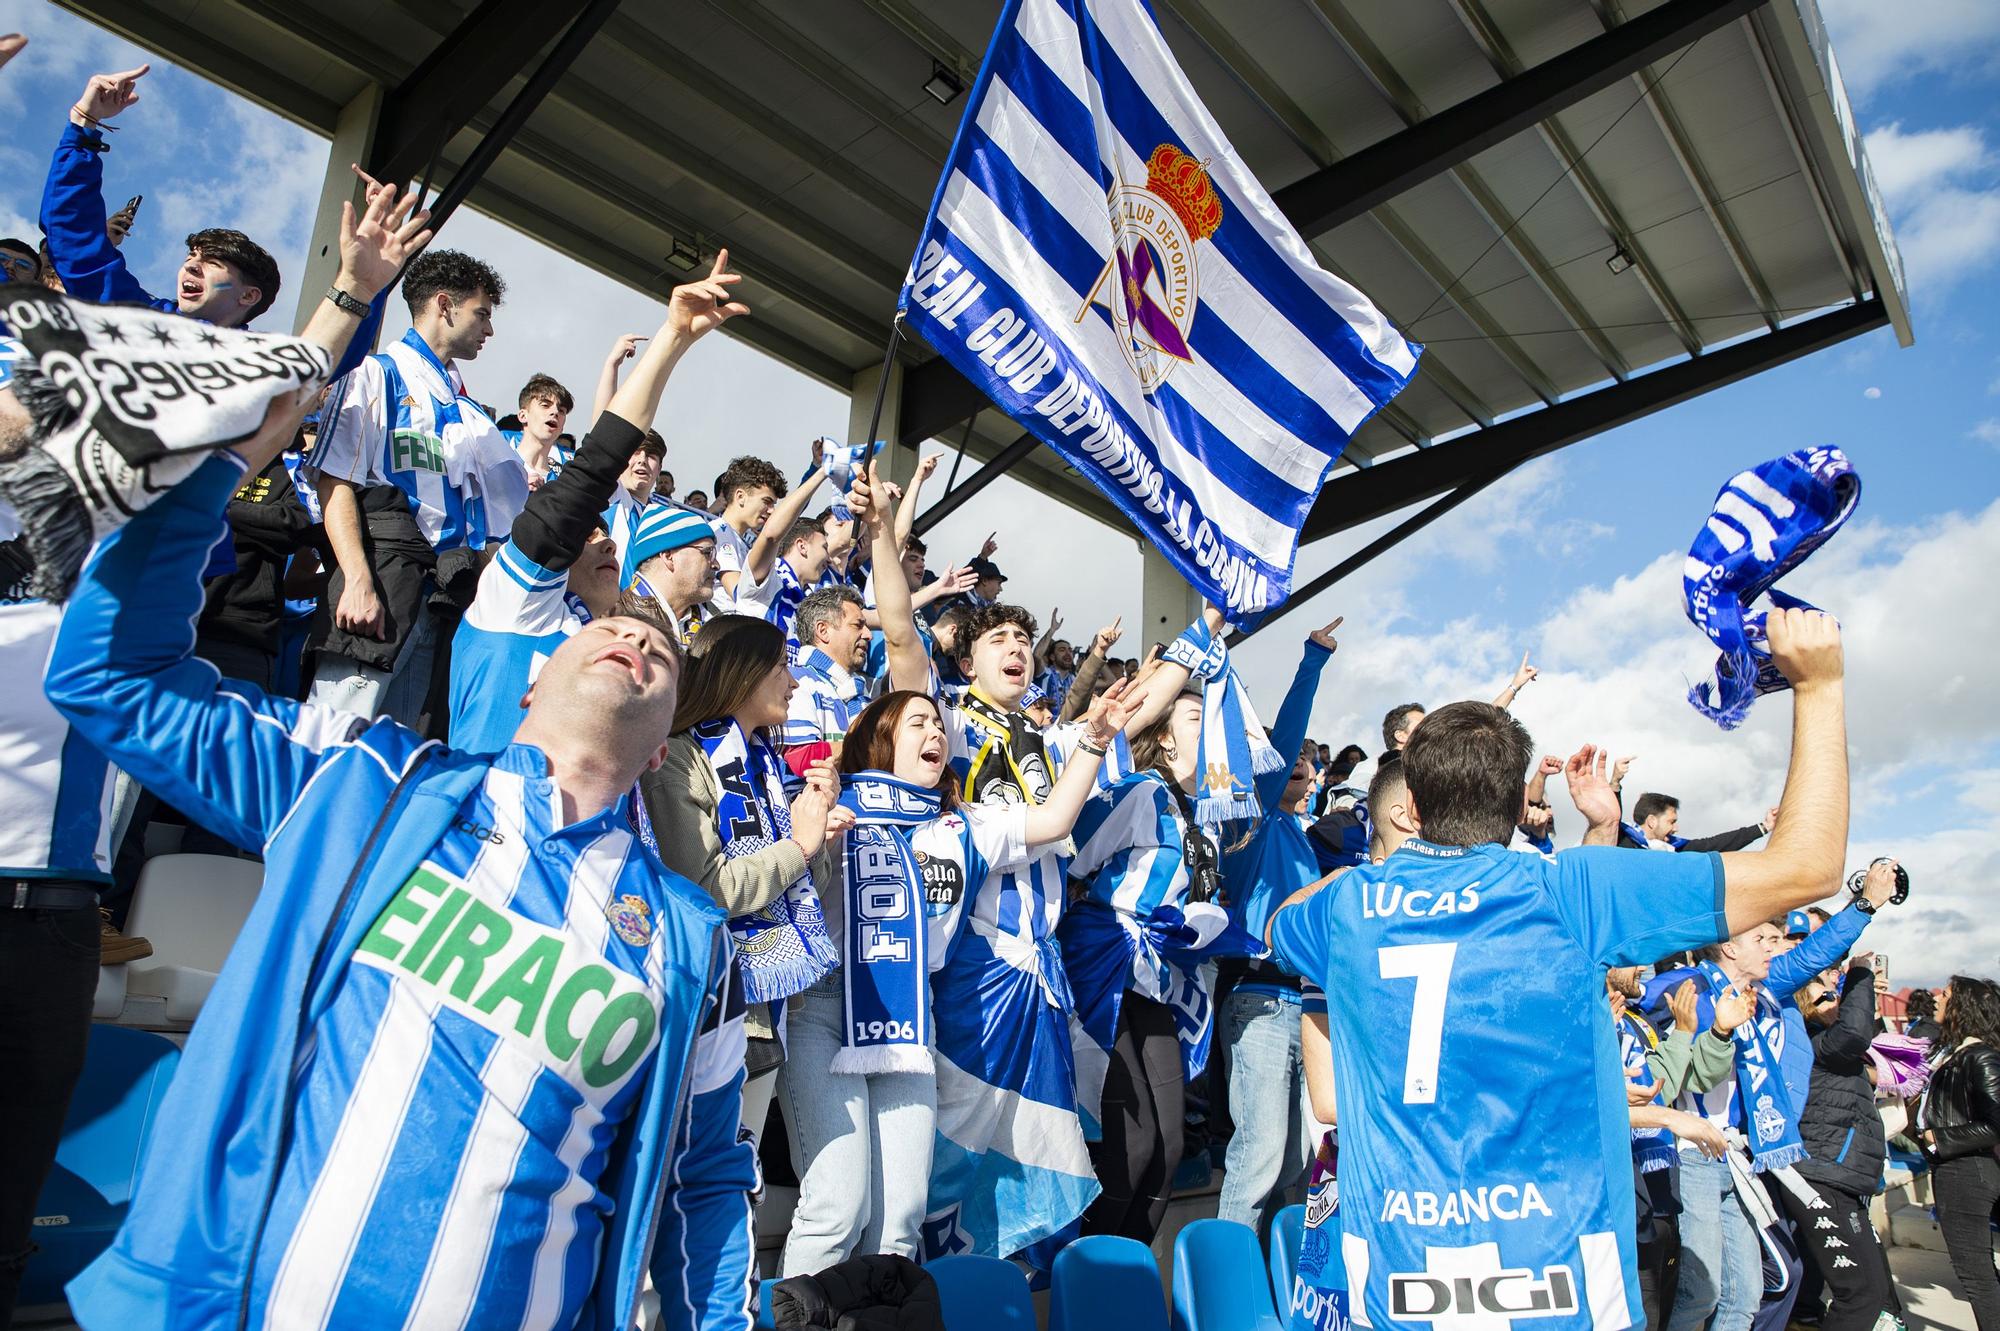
xmin=778 ymin=687 xmax=1132 ymax=1277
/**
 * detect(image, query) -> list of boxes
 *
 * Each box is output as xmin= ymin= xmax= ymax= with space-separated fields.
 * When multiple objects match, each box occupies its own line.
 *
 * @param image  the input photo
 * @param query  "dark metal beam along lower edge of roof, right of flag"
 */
xmin=1300 ymin=296 xmax=1888 ymax=542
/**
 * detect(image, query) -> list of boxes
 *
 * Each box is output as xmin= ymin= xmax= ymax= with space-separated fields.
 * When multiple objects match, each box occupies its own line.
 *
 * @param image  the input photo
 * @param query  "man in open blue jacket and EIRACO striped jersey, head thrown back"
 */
xmin=48 ymin=188 xmax=756 ymax=1331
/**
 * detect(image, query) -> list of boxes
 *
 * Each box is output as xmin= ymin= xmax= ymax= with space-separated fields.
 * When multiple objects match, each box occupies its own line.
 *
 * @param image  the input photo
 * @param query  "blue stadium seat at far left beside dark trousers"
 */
xmin=20 ymin=1025 xmax=180 ymax=1309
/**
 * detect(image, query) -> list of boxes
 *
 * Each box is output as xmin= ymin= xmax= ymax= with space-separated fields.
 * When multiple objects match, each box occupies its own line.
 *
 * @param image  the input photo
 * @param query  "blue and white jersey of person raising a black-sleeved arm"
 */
xmin=450 ymin=542 xmax=590 ymax=753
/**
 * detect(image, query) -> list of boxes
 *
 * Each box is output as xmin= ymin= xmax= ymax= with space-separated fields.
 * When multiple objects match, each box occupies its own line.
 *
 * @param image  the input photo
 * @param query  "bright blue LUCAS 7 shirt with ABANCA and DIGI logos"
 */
xmin=1272 ymin=841 xmax=1728 ymax=1331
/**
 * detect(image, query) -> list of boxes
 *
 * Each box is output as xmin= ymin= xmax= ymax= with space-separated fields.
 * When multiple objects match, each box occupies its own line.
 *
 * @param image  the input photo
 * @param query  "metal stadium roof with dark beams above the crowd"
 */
xmin=60 ymin=0 xmax=1910 ymax=563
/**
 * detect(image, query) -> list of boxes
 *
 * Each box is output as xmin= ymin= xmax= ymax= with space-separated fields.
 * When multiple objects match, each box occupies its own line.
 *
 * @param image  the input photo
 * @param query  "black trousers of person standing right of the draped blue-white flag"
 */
xmin=1084 ymin=991 xmax=1176 ymax=1239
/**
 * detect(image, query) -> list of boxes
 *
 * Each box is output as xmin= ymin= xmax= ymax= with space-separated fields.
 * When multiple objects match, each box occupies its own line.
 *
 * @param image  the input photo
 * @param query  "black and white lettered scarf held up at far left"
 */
xmin=0 ymin=282 xmax=332 ymax=602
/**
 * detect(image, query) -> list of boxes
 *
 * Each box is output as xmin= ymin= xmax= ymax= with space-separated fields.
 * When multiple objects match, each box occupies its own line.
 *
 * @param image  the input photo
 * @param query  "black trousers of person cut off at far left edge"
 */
xmin=0 ymin=907 xmax=98 ymax=1327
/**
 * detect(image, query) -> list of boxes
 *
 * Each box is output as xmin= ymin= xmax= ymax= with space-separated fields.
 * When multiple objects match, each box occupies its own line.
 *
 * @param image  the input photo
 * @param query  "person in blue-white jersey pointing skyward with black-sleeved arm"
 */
xmin=450 ymin=250 xmax=748 ymax=753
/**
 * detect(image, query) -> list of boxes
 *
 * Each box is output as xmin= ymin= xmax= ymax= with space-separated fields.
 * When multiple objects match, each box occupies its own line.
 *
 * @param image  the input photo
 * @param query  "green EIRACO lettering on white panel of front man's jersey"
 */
xmin=354 ymin=863 xmax=660 ymax=1105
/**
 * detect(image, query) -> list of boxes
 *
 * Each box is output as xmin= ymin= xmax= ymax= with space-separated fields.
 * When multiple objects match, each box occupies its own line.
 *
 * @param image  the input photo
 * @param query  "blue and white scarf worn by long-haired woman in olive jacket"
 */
xmin=690 ymin=717 xmax=840 ymax=1003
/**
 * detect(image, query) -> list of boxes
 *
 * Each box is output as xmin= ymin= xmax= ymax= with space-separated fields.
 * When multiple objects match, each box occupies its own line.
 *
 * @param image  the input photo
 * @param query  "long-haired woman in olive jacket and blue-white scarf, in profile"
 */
xmin=640 ymin=616 xmax=852 ymax=1135
